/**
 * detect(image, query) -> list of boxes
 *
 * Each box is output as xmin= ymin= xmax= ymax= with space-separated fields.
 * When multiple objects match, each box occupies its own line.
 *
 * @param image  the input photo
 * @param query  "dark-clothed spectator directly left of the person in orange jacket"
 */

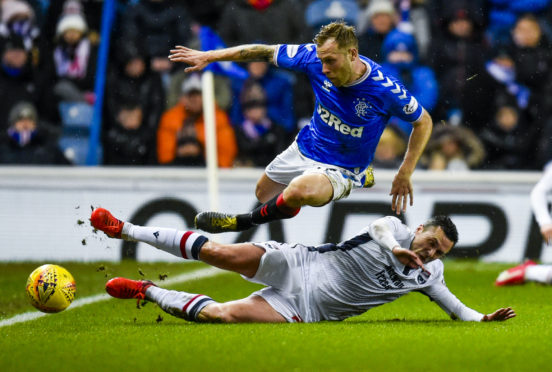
xmin=104 ymin=98 xmax=156 ymax=165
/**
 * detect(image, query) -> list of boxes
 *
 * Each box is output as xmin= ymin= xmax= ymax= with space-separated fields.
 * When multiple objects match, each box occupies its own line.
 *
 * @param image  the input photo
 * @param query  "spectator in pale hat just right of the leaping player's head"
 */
xmin=358 ymin=0 xmax=399 ymax=63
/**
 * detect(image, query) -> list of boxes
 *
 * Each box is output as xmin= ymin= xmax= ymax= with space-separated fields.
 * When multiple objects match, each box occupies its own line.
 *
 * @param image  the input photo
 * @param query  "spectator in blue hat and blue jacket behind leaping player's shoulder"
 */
xmin=382 ymin=30 xmax=439 ymax=135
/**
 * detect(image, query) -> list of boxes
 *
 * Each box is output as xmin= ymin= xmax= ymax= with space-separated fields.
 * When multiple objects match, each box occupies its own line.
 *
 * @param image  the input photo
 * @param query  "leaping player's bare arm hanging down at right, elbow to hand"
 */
xmin=389 ymin=110 xmax=433 ymax=214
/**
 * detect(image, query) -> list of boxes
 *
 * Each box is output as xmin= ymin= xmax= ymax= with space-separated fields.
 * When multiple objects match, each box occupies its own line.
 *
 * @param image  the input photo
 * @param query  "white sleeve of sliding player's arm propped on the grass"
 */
xmin=422 ymin=263 xmax=483 ymax=322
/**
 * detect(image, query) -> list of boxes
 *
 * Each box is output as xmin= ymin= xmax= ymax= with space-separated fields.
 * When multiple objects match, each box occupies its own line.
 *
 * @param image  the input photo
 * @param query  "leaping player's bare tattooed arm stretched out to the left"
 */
xmin=169 ymin=44 xmax=276 ymax=72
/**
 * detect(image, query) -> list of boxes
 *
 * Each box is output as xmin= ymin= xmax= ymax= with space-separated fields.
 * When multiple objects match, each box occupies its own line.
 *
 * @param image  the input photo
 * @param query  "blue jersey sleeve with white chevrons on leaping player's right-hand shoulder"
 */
xmin=378 ymin=70 xmax=424 ymax=123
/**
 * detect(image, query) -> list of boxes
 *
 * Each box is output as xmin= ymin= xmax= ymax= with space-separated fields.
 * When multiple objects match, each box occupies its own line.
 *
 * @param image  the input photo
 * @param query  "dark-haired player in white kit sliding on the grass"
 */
xmin=90 ymin=208 xmax=515 ymax=323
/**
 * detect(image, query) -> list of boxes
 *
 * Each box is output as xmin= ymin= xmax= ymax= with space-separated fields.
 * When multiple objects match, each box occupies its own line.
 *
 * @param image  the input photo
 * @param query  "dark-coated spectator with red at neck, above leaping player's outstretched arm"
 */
xmin=218 ymin=0 xmax=310 ymax=46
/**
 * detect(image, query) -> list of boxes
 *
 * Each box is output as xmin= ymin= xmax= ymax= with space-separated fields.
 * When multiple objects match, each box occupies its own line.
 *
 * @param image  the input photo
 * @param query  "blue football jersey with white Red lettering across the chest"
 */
xmin=274 ymin=44 xmax=423 ymax=173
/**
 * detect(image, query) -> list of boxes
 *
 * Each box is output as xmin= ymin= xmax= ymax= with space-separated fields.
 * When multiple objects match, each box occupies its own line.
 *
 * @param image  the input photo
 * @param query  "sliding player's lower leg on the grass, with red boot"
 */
xmin=105 ymin=278 xmax=286 ymax=323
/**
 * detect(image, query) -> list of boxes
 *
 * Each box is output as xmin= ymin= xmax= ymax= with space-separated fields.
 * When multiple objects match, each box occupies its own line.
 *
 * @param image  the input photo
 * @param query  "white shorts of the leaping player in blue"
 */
xmin=265 ymin=141 xmax=366 ymax=200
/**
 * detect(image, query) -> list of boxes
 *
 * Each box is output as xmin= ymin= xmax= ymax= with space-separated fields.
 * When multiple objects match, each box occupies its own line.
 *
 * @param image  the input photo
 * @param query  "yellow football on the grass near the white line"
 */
xmin=26 ymin=265 xmax=76 ymax=313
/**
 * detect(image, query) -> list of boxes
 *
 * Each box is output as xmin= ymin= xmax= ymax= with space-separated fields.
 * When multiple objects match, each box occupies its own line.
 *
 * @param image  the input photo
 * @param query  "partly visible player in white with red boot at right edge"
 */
xmin=495 ymin=161 xmax=552 ymax=286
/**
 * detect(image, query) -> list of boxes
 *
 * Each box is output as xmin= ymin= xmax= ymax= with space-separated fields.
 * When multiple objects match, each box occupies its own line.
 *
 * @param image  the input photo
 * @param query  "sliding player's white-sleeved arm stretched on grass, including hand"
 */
xmin=422 ymin=282 xmax=516 ymax=322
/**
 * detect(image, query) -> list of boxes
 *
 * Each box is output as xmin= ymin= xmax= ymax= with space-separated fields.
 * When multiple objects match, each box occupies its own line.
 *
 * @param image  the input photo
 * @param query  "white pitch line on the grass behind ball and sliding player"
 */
xmin=0 ymin=267 xmax=227 ymax=328
